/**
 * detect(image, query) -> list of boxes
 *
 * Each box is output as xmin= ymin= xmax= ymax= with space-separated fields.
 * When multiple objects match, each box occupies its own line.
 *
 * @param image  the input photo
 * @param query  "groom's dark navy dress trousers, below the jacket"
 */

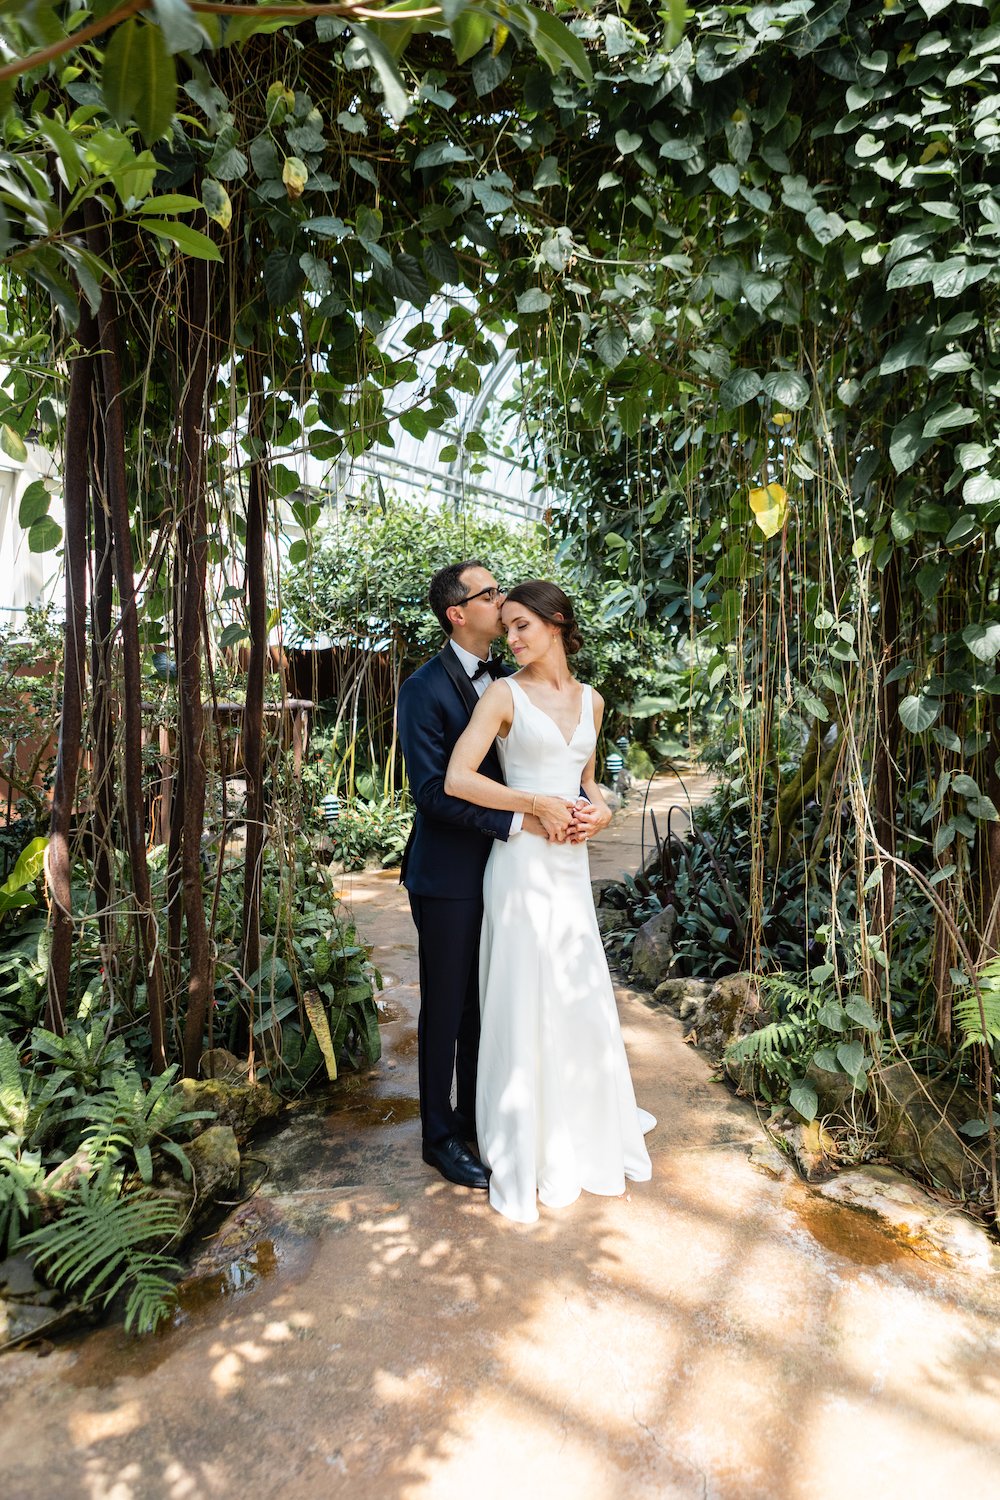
xmin=409 ymin=891 xmax=483 ymax=1145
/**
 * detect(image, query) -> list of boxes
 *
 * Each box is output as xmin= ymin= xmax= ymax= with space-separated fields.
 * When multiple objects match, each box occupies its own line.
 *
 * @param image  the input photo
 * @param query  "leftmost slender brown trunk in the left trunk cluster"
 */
xmin=45 ymin=306 xmax=96 ymax=1037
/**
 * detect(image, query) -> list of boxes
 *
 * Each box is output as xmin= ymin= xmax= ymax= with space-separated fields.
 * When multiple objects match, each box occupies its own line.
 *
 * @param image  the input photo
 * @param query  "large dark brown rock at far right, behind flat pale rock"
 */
xmin=876 ymin=1062 xmax=987 ymax=1199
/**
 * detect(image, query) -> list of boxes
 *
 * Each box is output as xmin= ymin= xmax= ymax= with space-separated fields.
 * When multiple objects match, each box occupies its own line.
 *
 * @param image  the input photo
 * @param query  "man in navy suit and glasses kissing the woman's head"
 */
xmin=399 ymin=560 xmax=546 ymax=1188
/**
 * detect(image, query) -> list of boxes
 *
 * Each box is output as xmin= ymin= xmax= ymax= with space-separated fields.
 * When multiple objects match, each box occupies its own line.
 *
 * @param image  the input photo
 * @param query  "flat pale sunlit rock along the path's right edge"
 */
xmin=817 ymin=1167 xmax=1000 ymax=1272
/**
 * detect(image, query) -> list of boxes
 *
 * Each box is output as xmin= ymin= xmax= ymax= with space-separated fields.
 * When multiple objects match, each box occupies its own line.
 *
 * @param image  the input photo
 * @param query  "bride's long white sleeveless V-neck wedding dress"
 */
xmin=475 ymin=678 xmax=655 ymax=1224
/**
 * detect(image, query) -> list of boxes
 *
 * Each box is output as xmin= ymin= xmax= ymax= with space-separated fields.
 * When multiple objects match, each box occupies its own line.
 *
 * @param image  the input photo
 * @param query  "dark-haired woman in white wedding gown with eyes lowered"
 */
xmin=445 ymin=581 xmax=655 ymax=1224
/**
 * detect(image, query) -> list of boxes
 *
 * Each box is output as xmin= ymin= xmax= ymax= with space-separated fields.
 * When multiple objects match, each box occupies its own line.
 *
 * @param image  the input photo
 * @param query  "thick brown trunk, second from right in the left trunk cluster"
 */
xmin=177 ymin=261 xmax=213 ymax=1077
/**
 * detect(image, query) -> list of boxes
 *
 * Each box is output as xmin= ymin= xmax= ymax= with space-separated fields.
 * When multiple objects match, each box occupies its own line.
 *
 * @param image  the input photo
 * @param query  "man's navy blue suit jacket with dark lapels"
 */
xmin=399 ymin=645 xmax=514 ymax=900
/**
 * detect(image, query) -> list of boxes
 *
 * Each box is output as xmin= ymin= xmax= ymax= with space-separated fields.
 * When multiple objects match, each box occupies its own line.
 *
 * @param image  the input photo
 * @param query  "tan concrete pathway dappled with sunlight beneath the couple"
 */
xmin=0 ymin=786 xmax=1000 ymax=1500
